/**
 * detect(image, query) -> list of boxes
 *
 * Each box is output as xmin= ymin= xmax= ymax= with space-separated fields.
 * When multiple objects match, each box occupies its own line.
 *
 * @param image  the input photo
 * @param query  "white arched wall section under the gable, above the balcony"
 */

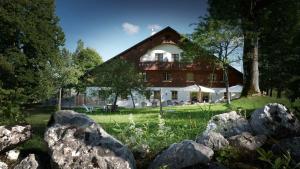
xmin=140 ymin=44 xmax=183 ymax=62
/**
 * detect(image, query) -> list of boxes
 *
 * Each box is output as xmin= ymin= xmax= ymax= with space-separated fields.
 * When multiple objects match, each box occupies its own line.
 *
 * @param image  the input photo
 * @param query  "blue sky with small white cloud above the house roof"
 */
xmin=56 ymin=0 xmax=207 ymax=61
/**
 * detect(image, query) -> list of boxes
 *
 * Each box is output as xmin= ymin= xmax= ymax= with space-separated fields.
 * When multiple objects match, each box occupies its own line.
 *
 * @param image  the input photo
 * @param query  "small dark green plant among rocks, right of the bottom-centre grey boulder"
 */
xmin=215 ymin=146 xmax=241 ymax=166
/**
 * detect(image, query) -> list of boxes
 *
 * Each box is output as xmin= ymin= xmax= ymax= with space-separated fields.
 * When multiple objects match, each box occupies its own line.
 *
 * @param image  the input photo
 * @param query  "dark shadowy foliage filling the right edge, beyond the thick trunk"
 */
xmin=260 ymin=0 xmax=300 ymax=97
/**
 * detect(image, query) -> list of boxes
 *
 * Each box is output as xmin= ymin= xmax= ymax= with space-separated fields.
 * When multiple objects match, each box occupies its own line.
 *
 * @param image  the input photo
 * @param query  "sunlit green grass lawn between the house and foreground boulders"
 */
xmin=22 ymin=96 xmax=300 ymax=159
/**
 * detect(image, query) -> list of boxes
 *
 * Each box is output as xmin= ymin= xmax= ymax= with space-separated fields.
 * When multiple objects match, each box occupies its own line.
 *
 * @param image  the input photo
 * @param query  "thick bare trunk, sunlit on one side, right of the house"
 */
xmin=242 ymin=33 xmax=260 ymax=96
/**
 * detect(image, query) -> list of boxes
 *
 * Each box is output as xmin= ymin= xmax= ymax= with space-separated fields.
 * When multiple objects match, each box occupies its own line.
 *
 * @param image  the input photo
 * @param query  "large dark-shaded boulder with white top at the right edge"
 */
xmin=250 ymin=103 xmax=300 ymax=138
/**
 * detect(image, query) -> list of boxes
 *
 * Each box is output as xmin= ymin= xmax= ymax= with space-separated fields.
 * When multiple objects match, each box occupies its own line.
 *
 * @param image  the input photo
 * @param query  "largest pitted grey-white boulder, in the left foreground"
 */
xmin=44 ymin=110 xmax=136 ymax=169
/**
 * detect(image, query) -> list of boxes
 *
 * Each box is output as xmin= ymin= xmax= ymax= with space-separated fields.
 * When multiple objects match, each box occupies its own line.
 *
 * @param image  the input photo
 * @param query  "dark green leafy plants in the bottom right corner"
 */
xmin=256 ymin=148 xmax=300 ymax=169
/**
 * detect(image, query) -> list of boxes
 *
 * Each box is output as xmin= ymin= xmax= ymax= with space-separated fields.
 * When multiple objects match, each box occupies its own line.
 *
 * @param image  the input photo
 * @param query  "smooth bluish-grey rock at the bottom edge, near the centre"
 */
xmin=149 ymin=140 xmax=214 ymax=169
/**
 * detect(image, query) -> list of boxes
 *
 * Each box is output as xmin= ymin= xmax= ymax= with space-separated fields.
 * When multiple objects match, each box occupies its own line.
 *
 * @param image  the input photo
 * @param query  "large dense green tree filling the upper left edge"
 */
xmin=0 ymin=0 xmax=64 ymax=121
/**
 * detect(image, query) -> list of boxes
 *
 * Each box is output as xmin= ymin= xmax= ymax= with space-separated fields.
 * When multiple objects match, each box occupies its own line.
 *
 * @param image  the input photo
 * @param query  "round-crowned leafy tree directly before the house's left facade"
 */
xmin=91 ymin=59 xmax=145 ymax=111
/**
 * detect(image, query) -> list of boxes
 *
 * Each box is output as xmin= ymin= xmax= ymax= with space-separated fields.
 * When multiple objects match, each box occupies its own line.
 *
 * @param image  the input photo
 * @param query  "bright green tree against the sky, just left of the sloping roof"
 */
xmin=73 ymin=40 xmax=103 ymax=93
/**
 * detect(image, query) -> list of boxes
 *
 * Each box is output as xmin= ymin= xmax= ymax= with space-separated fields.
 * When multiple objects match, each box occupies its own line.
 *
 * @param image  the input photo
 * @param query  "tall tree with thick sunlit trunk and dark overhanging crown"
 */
xmin=208 ymin=0 xmax=270 ymax=96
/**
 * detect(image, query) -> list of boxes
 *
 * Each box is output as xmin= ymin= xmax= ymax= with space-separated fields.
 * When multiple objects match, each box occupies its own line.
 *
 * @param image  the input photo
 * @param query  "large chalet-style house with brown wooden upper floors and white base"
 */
xmin=86 ymin=27 xmax=243 ymax=107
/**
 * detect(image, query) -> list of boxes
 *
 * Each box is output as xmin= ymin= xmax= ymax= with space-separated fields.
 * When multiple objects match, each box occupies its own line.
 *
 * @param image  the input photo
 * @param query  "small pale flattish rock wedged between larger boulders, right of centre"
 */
xmin=196 ymin=131 xmax=229 ymax=150
